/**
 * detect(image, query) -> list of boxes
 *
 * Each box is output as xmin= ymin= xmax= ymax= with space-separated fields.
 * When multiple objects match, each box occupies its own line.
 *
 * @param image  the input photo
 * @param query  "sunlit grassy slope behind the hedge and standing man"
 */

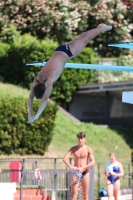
xmin=0 ymin=83 xmax=133 ymax=162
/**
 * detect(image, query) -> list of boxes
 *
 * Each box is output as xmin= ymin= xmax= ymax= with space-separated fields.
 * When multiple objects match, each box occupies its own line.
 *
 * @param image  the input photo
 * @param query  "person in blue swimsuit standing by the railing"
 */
xmin=104 ymin=153 xmax=124 ymax=200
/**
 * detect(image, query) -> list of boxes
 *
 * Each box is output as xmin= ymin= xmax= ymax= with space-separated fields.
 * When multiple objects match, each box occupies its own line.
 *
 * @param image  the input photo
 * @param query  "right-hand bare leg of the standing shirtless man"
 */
xmin=81 ymin=173 xmax=90 ymax=200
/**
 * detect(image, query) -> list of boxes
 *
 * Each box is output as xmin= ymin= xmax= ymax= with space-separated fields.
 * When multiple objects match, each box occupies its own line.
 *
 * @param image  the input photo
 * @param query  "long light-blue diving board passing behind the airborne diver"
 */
xmin=26 ymin=62 xmax=133 ymax=72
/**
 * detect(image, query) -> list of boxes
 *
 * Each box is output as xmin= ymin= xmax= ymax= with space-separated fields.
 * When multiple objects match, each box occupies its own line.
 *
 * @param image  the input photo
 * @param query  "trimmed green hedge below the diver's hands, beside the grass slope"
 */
xmin=0 ymin=95 xmax=57 ymax=155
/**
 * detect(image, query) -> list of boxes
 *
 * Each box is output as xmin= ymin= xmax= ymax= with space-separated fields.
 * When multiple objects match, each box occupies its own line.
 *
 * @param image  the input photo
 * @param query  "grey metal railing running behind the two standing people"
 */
xmin=0 ymin=158 xmax=132 ymax=200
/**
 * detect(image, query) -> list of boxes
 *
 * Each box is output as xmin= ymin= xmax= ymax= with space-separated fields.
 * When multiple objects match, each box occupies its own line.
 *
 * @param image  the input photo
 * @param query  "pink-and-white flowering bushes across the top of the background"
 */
xmin=0 ymin=0 xmax=133 ymax=57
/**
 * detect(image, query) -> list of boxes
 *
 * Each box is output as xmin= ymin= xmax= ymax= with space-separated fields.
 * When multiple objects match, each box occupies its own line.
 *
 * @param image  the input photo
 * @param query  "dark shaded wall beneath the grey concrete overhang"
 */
xmin=69 ymin=91 xmax=133 ymax=126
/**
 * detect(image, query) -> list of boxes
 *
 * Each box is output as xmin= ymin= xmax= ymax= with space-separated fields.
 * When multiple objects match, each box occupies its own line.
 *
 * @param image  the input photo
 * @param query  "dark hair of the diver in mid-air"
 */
xmin=34 ymin=83 xmax=45 ymax=99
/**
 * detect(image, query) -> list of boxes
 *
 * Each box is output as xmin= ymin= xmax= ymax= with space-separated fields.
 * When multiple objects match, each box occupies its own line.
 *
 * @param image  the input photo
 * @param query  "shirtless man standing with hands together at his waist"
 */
xmin=63 ymin=132 xmax=95 ymax=200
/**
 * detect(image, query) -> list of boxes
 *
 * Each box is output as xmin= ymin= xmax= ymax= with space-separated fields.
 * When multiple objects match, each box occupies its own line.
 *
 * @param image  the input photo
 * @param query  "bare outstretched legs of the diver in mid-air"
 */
xmin=68 ymin=24 xmax=112 ymax=56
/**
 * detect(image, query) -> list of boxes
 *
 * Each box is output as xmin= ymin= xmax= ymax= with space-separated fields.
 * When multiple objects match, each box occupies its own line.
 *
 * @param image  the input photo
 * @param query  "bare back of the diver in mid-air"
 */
xmin=38 ymin=52 xmax=68 ymax=82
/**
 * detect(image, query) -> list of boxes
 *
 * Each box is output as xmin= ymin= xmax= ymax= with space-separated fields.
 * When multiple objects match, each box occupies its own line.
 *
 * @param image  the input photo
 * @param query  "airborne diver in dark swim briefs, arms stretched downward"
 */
xmin=28 ymin=24 xmax=112 ymax=123
